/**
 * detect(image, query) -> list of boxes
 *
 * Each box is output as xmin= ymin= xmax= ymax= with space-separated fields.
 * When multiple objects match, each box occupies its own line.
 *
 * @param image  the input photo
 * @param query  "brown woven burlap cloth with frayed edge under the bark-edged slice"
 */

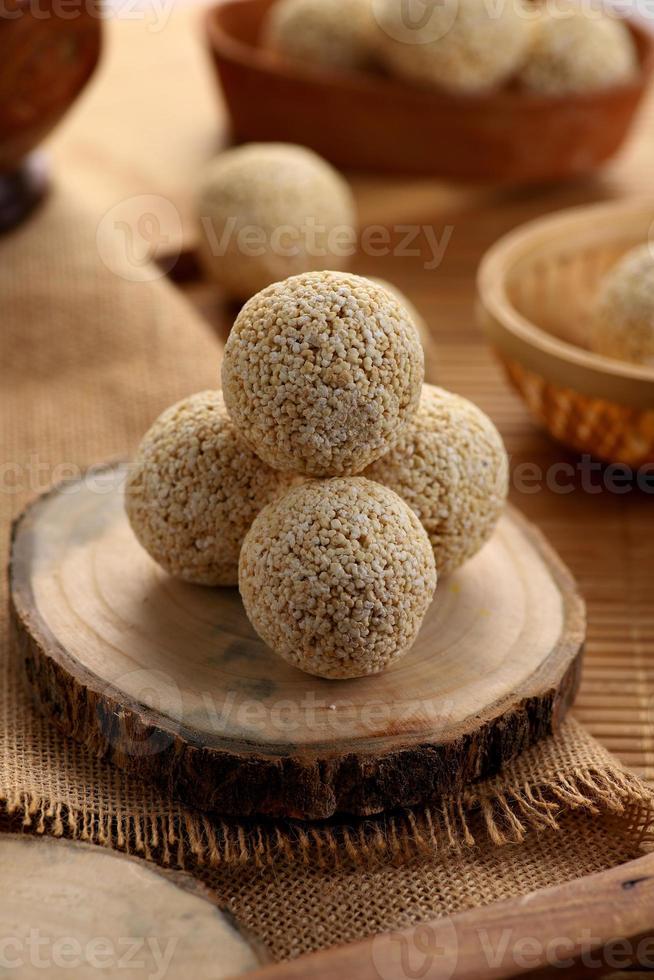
xmin=0 ymin=188 xmax=652 ymax=957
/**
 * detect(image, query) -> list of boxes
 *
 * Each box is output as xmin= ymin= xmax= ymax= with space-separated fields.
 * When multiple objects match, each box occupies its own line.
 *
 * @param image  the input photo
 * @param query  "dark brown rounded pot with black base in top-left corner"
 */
xmin=0 ymin=0 xmax=101 ymax=230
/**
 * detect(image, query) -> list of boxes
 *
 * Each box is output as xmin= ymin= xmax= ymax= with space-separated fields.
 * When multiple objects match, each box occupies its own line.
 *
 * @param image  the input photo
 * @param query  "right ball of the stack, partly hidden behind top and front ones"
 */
xmin=365 ymin=385 xmax=508 ymax=576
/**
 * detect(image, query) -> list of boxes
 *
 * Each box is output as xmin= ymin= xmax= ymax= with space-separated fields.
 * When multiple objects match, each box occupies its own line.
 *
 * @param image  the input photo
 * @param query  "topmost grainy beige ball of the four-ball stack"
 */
xmin=222 ymin=272 xmax=424 ymax=476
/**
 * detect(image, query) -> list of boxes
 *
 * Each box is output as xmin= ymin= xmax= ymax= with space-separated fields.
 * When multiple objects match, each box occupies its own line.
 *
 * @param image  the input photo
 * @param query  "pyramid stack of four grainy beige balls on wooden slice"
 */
xmin=125 ymin=272 xmax=508 ymax=678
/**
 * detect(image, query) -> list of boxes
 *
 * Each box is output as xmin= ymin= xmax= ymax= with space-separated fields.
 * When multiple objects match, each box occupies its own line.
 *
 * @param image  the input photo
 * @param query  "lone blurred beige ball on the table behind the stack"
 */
xmin=196 ymin=143 xmax=357 ymax=299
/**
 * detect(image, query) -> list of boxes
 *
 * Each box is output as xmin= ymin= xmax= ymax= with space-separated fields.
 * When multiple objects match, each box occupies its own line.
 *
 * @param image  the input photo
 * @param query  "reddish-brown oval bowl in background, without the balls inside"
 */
xmin=206 ymin=0 xmax=654 ymax=182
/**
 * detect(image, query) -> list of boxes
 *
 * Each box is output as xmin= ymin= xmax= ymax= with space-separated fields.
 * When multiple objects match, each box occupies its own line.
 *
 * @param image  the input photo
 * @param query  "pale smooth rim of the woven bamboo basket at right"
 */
xmin=477 ymin=196 xmax=654 ymax=410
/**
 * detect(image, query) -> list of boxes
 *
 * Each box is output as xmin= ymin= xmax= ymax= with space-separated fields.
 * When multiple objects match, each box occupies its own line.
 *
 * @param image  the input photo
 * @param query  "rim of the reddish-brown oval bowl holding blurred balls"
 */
xmin=203 ymin=0 xmax=654 ymax=112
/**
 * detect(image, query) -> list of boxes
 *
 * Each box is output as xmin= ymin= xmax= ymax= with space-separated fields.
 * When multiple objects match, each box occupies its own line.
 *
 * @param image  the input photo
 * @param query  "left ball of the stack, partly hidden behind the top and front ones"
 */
xmin=125 ymin=391 xmax=291 ymax=585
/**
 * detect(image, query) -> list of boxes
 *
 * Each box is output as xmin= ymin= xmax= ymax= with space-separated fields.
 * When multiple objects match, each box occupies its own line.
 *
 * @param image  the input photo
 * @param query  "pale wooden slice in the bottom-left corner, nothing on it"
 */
xmin=0 ymin=834 xmax=270 ymax=980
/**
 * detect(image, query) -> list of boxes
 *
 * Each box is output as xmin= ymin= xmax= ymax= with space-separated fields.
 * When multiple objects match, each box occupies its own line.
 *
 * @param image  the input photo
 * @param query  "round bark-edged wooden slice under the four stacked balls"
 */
xmin=10 ymin=467 xmax=585 ymax=819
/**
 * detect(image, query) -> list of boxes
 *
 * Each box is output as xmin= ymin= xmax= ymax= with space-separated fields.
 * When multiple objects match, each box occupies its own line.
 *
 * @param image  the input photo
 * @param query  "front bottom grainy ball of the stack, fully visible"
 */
xmin=239 ymin=477 xmax=436 ymax=678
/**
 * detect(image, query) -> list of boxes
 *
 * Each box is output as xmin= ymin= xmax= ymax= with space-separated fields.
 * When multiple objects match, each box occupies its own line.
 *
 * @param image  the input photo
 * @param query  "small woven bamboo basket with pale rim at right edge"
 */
xmin=478 ymin=201 xmax=654 ymax=466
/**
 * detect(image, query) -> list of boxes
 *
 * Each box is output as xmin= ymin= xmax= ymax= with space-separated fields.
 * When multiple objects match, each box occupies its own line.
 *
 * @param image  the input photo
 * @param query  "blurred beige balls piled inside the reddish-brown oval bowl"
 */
xmin=263 ymin=0 xmax=638 ymax=96
